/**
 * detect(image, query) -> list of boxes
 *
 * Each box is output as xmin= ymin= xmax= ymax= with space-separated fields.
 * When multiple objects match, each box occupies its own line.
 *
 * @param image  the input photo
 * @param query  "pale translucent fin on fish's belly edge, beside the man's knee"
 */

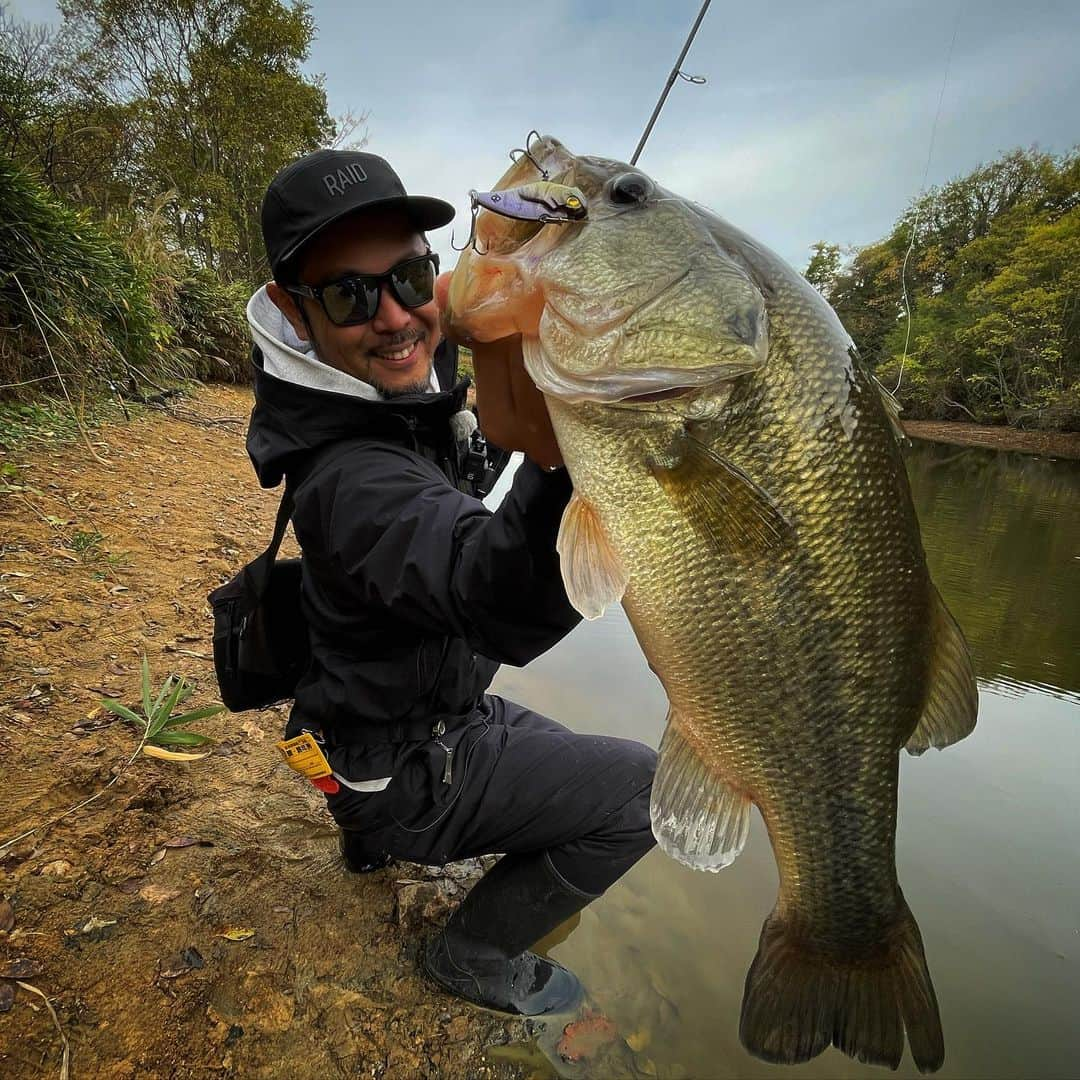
xmin=649 ymin=711 xmax=751 ymax=872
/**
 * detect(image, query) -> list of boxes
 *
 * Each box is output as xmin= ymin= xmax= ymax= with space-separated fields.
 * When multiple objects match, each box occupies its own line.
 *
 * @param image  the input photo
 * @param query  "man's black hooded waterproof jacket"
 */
xmin=247 ymin=348 xmax=580 ymax=745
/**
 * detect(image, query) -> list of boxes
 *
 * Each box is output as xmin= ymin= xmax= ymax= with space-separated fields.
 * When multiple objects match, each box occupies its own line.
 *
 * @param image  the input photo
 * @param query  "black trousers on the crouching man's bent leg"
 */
xmin=327 ymin=696 xmax=657 ymax=894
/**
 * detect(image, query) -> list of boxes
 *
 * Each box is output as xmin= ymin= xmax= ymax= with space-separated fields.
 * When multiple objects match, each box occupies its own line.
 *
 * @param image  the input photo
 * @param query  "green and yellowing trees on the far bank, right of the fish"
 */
xmin=804 ymin=148 xmax=1080 ymax=431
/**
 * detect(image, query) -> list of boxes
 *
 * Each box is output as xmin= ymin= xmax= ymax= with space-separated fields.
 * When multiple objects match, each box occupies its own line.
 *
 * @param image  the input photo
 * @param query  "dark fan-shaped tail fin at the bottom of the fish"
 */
xmin=739 ymin=904 xmax=945 ymax=1072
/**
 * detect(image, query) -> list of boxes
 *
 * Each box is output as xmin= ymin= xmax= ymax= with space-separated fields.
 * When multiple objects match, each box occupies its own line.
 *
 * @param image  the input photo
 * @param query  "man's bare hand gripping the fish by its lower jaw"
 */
xmin=436 ymin=272 xmax=563 ymax=469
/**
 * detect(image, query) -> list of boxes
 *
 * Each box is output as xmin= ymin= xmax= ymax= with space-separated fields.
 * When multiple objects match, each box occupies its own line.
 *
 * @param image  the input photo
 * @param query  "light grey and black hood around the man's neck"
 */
xmin=247 ymin=286 xmax=476 ymax=487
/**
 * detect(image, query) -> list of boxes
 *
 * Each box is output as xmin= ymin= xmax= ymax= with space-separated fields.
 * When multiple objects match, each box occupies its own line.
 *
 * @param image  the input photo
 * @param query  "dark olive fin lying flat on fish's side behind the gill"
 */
xmin=649 ymin=433 xmax=793 ymax=555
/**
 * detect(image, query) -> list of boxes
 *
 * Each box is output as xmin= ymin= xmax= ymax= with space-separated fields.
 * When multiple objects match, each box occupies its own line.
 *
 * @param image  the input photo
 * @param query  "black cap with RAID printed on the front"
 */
xmin=261 ymin=150 xmax=454 ymax=278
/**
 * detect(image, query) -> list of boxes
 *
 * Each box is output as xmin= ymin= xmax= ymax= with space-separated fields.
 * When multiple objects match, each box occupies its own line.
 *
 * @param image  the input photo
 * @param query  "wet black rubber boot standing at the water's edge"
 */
xmin=422 ymin=851 xmax=596 ymax=1016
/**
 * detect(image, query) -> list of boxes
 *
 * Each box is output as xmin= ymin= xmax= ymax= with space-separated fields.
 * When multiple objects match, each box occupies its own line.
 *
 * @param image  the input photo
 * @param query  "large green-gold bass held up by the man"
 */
xmin=448 ymin=138 xmax=977 ymax=1071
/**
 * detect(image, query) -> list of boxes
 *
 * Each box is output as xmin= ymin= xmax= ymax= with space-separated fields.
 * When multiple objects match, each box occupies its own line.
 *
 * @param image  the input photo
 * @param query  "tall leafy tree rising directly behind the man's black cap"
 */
xmin=60 ymin=0 xmax=334 ymax=282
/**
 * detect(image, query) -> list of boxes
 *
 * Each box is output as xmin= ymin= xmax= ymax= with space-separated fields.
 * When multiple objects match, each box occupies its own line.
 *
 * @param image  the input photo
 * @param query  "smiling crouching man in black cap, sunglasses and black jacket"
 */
xmin=247 ymin=150 xmax=656 ymax=1015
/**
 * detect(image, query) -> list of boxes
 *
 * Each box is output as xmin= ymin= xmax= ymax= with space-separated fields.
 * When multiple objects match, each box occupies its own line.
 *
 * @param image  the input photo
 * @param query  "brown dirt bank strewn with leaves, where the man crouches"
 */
xmin=0 ymin=389 xmax=544 ymax=1080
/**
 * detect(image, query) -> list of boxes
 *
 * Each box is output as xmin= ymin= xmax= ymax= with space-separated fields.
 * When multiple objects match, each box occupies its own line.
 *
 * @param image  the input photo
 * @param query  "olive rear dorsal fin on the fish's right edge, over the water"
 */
xmin=906 ymin=585 xmax=978 ymax=754
